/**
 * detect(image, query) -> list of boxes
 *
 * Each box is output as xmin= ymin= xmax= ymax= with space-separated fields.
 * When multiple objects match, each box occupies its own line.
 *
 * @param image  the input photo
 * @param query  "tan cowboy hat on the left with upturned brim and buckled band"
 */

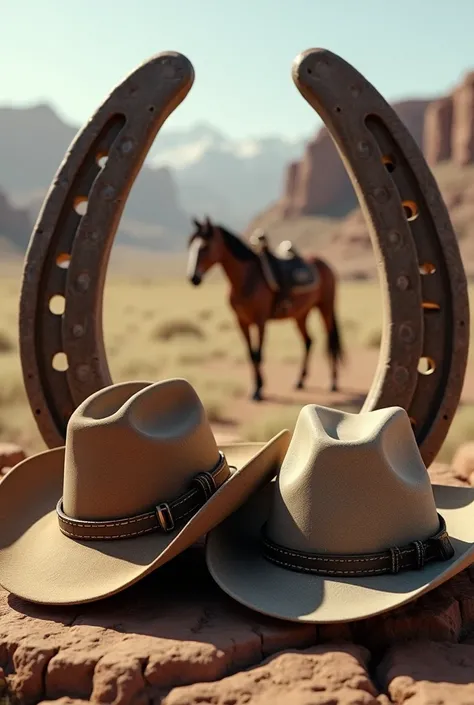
xmin=0 ymin=379 xmax=290 ymax=604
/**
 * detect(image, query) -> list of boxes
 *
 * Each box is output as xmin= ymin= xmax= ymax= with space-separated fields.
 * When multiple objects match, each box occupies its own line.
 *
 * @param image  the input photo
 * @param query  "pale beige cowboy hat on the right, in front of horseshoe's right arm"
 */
xmin=206 ymin=405 xmax=474 ymax=622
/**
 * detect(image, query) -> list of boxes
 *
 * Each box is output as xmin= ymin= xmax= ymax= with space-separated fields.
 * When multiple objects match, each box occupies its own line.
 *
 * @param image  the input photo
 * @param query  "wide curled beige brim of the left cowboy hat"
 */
xmin=0 ymin=430 xmax=290 ymax=605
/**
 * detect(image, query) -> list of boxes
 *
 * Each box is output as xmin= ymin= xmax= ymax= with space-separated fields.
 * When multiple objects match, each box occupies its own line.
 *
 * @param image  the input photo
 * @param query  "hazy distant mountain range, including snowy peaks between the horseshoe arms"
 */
xmin=0 ymin=104 xmax=305 ymax=251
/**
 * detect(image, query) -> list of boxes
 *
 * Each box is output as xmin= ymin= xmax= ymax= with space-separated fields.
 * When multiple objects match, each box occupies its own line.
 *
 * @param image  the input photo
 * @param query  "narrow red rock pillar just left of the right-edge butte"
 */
xmin=423 ymin=96 xmax=453 ymax=166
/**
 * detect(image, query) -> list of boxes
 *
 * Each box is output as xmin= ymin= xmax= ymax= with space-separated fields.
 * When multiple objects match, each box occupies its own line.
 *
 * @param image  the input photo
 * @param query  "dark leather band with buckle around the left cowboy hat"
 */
xmin=56 ymin=452 xmax=230 ymax=541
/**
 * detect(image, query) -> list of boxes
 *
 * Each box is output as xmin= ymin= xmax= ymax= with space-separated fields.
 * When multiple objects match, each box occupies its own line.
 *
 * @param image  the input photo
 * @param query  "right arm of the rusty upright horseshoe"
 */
xmin=292 ymin=49 xmax=469 ymax=466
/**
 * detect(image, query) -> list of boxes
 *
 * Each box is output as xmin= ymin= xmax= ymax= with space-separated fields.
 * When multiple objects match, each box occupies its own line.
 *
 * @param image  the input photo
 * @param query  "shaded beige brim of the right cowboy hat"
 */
xmin=206 ymin=481 xmax=474 ymax=623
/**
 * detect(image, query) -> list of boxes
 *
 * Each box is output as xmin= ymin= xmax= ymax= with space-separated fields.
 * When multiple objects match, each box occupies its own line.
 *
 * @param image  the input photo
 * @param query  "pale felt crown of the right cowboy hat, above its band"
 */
xmin=267 ymin=405 xmax=438 ymax=554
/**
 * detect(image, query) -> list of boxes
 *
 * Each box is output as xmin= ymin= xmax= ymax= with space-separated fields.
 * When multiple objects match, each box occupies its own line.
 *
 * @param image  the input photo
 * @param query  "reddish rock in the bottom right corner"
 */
xmin=377 ymin=641 xmax=474 ymax=705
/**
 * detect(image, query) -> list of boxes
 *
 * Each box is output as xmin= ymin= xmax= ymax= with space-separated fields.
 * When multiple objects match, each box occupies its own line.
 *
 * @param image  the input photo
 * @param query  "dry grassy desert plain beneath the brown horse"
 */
xmin=0 ymin=249 xmax=474 ymax=462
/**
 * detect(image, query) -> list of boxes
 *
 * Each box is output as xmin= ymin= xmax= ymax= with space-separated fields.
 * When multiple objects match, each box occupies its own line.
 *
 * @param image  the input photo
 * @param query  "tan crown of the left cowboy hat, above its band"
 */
xmin=63 ymin=379 xmax=219 ymax=520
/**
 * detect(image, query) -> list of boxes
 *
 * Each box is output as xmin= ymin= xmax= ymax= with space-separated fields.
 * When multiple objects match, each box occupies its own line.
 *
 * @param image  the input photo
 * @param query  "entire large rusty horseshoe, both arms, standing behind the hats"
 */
xmin=20 ymin=49 xmax=469 ymax=465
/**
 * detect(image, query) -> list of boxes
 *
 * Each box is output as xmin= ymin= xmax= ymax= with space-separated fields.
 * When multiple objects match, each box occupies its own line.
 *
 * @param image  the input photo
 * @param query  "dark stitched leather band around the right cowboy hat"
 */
xmin=262 ymin=514 xmax=454 ymax=577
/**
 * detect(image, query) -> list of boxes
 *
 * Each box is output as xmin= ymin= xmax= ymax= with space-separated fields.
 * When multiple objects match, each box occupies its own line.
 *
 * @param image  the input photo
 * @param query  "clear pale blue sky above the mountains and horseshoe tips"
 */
xmin=0 ymin=0 xmax=474 ymax=138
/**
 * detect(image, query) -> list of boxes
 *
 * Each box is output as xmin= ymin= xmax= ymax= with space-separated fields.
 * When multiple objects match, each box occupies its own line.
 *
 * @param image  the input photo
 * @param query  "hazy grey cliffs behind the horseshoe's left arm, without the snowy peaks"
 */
xmin=0 ymin=105 xmax=190 ymax=251
